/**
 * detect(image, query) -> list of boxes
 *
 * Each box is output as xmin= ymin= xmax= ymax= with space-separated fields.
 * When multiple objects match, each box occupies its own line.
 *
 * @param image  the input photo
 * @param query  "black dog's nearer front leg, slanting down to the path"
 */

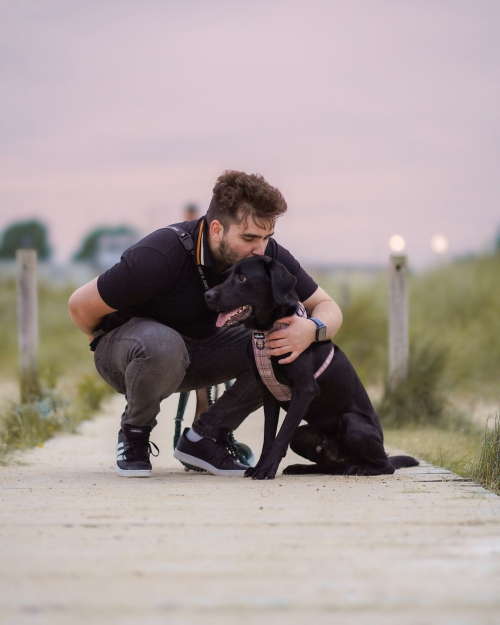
xmin=250 ymin=388 xmax=317 ymax=480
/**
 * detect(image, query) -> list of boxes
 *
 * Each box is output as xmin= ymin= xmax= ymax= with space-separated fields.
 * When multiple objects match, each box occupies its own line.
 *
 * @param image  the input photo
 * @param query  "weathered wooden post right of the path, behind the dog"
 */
xmin=389 ymin=254 xmax=409 ymax=390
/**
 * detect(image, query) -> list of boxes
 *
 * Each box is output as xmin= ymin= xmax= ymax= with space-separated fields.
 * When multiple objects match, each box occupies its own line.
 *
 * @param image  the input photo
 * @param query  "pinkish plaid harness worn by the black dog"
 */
xmin=252 ymin=302 xmax=335 ymax=401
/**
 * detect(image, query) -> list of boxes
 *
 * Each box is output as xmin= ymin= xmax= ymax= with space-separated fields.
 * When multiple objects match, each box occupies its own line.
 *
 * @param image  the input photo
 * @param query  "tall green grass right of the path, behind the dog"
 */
xmin=322 ymin=254 xmax=500 ymax=492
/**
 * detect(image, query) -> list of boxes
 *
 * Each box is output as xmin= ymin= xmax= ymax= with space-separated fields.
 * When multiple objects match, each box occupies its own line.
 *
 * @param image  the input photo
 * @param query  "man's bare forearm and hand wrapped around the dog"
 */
xmin=267 ymin=286 xmax=342 ymax=365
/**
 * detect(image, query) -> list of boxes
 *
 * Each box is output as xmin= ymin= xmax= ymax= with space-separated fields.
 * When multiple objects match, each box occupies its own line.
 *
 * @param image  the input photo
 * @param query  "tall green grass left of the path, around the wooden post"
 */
xmin=0 ymin=279 xmax=113 ymax=462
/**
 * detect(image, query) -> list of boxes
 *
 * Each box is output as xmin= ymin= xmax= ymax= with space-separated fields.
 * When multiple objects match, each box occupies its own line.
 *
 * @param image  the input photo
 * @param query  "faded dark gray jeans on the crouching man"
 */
xmin=94 ymin=317 xmax=262 ymax=437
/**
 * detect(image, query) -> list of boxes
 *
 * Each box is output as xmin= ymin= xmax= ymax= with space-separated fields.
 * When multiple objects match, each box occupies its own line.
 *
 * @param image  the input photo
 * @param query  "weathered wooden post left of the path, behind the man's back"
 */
xmin=16 ymin=250 xmax=40 ymax=403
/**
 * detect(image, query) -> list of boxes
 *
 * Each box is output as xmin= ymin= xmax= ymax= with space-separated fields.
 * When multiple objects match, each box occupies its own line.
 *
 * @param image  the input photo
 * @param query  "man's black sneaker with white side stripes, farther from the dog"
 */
xmin=116 ymin=425 xmax=160 ymax=477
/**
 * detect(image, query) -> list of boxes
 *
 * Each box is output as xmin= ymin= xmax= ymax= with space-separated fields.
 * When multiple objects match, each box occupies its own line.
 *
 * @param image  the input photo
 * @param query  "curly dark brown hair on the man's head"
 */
xmin=207 ymin=169 xmax=287 ymax=228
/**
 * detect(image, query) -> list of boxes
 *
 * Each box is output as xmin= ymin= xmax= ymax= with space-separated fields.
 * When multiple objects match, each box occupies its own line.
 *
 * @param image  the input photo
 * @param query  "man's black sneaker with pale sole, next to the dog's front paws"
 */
xmin=174 ymin=428 xmax=248 ymax=475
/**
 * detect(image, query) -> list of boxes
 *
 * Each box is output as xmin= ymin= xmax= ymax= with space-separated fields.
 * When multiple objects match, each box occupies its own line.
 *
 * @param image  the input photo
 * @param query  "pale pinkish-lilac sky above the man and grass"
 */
xmin=0 ymin=0 xmax=500 ymax=267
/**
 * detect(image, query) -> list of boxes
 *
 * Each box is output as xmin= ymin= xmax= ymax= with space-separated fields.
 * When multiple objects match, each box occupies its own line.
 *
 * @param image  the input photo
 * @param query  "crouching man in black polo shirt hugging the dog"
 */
xmin=69 ymin=171 xmax=342 ymax=477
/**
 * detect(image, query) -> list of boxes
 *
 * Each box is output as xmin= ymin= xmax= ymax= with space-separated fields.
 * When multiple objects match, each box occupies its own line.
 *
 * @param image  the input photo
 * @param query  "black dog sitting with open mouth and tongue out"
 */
xmin=205 ymin=256 xmax=418 ymax=479
